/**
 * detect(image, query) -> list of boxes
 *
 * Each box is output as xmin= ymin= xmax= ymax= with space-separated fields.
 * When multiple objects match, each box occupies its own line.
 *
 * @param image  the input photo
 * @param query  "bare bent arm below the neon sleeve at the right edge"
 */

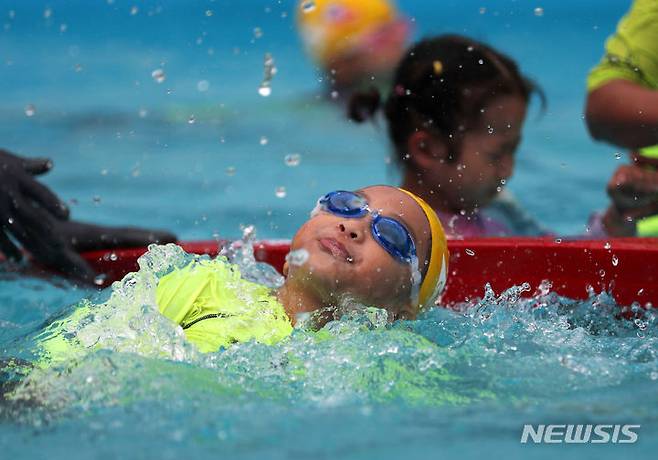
xmin=585 ymin=80 xmax=658 ymax=149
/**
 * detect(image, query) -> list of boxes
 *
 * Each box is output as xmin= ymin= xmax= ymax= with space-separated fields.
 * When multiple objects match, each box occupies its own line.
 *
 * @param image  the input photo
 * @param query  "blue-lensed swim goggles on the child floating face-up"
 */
xmin=318 ymin=190 xmax=416 ymax=264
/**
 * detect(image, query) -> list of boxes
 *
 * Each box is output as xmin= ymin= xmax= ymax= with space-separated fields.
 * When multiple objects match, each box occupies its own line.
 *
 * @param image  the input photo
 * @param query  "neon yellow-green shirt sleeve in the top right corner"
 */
xmin=587 ymin=0 xmax=658 ymax=91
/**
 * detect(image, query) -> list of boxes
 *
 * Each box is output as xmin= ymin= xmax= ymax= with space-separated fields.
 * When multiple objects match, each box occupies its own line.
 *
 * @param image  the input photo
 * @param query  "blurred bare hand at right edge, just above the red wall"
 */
xmin=604 ymin=164 xmax=658 ymax=236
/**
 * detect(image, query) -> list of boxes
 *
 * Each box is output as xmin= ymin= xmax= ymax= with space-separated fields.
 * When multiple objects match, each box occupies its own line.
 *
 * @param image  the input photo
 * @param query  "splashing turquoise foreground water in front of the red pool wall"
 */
xmin=0 ymin=245 xmax=658 ymax=459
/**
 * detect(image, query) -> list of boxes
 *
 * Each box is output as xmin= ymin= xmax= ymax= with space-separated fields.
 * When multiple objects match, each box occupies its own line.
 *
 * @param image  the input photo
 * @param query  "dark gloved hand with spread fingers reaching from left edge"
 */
xmin=0 ymin=149 xmax=176 ymax=282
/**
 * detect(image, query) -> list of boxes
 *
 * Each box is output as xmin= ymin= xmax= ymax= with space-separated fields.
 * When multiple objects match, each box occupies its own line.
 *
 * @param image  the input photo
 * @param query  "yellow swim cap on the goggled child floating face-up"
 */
xmin=400 ymin=188 xmax=450 ymax=309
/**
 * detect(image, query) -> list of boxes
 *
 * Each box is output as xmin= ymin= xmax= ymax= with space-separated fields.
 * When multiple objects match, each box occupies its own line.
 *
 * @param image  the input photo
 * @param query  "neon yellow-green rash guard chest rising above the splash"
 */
xmin=156 ymin=260 xmax=292 ymax=352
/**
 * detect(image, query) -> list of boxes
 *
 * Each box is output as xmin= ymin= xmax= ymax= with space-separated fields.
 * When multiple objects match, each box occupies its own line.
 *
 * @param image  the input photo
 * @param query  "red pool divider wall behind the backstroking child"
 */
xmin=78 ymin=238 xmax=658 ymax=306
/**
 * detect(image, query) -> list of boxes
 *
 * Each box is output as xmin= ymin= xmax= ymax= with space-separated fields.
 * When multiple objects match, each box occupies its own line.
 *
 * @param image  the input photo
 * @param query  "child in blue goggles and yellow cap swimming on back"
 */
xmin=37 ymin=186 xmax=448 ymax=366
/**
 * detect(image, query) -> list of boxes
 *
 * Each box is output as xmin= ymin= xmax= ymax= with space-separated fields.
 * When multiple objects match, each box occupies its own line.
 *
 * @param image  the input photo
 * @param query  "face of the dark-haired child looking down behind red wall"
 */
xmin=430 ymin=96 xmax=527 ymax=210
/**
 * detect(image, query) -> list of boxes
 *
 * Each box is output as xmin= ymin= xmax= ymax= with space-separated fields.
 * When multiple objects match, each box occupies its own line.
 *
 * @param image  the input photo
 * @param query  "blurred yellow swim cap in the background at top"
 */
xmin=297 ymin=0 xmax=398 ymax=64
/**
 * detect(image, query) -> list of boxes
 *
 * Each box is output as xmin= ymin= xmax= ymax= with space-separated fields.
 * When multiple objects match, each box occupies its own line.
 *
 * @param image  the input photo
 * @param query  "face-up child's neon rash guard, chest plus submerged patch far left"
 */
xmin=36 ymin=259 xmax=292 ymax=367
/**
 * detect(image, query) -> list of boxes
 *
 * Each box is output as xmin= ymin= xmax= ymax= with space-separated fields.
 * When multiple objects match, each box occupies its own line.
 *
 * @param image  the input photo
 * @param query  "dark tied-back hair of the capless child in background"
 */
xmin=348 ymin=35 xmax=546 ymax=167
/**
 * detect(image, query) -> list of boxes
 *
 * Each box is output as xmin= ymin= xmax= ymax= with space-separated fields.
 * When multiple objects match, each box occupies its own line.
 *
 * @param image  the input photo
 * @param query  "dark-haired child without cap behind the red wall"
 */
xmin=349 ymin=35 xmax=632 ymax=238
